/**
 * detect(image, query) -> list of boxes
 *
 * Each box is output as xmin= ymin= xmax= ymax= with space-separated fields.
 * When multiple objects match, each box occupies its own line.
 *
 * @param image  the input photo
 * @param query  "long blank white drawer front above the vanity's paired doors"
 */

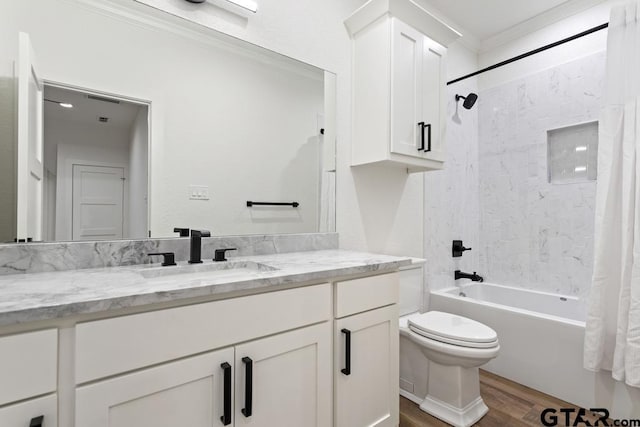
xmin=76 ymin=284 xmax=331 ymax=384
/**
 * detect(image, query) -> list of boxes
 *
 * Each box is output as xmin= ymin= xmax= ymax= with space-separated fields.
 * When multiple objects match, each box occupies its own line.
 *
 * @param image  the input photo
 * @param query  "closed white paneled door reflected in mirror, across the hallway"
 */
xmin=73 ymin=165 xmax=124 ymax=240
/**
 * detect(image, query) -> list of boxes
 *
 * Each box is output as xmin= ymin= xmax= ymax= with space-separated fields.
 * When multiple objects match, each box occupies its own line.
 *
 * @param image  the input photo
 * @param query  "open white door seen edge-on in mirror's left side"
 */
xmin=16 ymin=33 xmax=44 ymax=240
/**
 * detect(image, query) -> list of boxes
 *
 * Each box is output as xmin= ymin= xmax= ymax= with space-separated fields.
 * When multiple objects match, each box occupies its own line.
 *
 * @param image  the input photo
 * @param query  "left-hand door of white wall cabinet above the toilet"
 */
xmin=390 ymin=18 xmax=424 ymax=157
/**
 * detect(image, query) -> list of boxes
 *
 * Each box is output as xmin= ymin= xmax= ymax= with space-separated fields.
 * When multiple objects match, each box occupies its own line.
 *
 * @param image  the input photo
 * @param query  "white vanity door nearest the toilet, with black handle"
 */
xmin=334 ymin=304 xmax=399 ymax=427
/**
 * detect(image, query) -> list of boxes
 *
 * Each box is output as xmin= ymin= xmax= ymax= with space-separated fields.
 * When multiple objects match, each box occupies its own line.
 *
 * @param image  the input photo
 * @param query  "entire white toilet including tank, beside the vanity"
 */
xmin=399 ymin=263 xmax=500 ymax=427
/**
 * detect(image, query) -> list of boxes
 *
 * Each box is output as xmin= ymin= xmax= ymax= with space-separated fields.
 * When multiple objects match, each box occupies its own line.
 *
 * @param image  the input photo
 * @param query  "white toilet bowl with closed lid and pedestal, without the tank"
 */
xmin=400 ymin=311 xmax=500 ymax=427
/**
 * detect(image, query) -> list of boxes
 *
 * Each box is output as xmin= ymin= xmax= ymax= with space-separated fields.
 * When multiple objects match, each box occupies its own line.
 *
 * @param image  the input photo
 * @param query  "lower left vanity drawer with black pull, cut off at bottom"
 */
xmin=0 ymin=394 xmax=58 ymax=427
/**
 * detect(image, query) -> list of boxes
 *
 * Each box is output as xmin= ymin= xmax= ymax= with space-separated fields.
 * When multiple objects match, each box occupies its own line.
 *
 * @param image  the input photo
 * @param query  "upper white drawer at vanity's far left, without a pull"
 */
xmin=0 ymin=329 xmax=58 ymax=406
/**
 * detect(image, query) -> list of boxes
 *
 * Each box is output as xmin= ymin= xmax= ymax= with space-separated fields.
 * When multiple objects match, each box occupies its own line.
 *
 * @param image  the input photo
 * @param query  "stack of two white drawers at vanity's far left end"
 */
xmin=0 ymin=329 xmax=58 ymax=427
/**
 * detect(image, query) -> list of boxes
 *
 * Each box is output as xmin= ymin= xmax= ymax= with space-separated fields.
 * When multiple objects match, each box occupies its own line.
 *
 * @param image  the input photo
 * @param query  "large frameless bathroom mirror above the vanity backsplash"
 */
xmin=0 ymin=0 xmax=335 ymax=242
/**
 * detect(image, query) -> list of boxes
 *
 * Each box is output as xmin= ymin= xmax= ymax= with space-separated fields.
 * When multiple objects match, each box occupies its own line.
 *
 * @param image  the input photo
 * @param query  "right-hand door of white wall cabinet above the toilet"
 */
xmin=419 ymin=37 xmax=448 ymax=162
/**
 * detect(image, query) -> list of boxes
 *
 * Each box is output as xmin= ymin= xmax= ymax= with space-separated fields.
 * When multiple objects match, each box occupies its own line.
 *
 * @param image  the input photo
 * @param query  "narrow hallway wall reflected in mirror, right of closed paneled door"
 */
xmin=128 ymin=106 xmax=149 ymax=239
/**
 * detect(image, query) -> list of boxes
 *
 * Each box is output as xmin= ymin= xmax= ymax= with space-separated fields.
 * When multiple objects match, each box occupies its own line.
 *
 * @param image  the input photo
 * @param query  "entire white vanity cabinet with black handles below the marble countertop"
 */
xmin=0 ymin=271 xmax=399 ymax=427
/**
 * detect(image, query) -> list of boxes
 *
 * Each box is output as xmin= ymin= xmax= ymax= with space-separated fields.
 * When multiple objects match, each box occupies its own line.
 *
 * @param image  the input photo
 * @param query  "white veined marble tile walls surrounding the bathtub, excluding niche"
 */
xmin=424 ymin=52 xmax=606 ymax=296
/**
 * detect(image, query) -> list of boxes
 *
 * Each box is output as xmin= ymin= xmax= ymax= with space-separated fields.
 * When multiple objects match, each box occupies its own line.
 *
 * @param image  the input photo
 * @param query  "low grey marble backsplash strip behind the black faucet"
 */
xmin=0 ymin=233 xmax=338 ymax=276
